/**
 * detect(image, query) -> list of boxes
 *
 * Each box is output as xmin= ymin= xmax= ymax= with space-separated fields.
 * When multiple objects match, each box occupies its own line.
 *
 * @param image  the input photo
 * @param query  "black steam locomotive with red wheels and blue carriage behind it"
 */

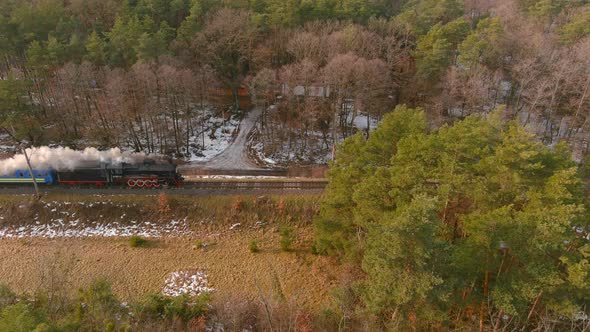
xmin=0 ymin=159 xmax=182 ymax=188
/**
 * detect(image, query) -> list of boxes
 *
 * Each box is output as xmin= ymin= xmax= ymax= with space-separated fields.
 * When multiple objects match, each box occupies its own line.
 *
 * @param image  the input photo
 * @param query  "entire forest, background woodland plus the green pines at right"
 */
xmin=0 ymin=0 xmax=590 ymax=331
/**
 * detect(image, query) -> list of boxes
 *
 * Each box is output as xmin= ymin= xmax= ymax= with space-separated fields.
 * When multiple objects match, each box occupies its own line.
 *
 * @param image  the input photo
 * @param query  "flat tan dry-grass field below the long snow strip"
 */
xmin=0 ymin=230 xmax=335 ymax=309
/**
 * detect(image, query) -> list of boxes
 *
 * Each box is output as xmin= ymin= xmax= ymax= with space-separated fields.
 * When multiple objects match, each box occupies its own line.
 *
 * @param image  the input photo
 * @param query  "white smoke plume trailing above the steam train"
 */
xmin=0 ymin=146 xmax=146 ymax=175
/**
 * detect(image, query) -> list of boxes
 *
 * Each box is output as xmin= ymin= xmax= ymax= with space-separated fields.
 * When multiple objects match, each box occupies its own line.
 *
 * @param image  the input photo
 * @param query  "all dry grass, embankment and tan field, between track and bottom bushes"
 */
xmin=0 ymin=194 xmax=339 ymax=310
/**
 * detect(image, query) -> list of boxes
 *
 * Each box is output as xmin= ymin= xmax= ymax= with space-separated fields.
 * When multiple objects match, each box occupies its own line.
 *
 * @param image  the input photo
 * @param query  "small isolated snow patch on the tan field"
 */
xmin=162 ymin=270 xmax=214 ymax=297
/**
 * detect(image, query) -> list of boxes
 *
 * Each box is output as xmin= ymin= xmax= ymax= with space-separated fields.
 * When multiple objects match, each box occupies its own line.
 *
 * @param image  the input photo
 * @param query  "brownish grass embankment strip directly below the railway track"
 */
xmin=0 ymin=194 xmax=319 ymax=233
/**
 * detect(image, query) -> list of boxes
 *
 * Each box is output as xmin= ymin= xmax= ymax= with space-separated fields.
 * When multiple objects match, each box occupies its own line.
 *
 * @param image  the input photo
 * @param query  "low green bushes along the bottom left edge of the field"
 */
xmin=0 ymin=279 xmax=210 ymax=332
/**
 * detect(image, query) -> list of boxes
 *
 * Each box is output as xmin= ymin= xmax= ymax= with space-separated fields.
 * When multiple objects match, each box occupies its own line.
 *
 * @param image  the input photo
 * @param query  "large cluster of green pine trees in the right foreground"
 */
xmin=316 ymin=105 xmax=589 ymax=329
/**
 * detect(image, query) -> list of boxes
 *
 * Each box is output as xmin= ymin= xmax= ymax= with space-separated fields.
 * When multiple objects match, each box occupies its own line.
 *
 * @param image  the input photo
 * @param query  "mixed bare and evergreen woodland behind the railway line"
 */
xmin=0 ymin=0 xmax=590 ymax=160
